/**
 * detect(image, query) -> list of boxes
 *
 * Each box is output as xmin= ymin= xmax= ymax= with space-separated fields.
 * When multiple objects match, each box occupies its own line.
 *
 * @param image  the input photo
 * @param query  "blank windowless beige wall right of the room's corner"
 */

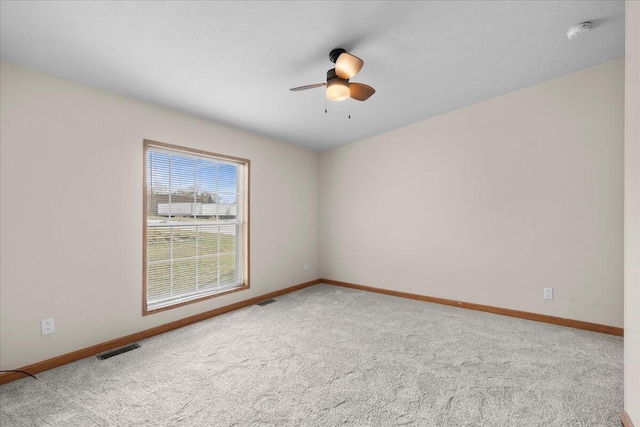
xmin=320 ymin=58 xmax=624 ymax=327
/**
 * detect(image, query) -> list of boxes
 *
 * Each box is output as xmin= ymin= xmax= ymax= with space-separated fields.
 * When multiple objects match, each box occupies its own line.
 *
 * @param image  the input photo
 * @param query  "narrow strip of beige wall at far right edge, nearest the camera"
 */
xmin=624 ymin=1 xmax=640 ymax=426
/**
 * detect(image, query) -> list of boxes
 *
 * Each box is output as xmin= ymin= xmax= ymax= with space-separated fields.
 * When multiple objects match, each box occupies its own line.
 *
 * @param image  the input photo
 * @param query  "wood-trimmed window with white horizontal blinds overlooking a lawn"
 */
xmin=143 ymin=140 xmax=249 ymax=314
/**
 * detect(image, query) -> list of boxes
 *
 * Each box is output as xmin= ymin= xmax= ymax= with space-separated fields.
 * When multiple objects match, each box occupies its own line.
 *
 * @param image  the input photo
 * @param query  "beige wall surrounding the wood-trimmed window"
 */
xmin=0 ymin=63 xmax=319 ymax=369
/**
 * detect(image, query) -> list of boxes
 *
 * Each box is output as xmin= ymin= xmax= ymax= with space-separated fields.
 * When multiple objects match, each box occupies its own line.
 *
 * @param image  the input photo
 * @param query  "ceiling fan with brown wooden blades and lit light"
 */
xmin=290 ymin=49 xmax=376 ymax=101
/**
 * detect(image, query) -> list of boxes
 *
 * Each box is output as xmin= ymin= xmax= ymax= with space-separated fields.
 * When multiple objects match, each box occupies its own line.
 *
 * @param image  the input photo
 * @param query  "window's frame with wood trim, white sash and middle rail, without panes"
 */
xmin=142 ymin=139 xmax=250 ymax=315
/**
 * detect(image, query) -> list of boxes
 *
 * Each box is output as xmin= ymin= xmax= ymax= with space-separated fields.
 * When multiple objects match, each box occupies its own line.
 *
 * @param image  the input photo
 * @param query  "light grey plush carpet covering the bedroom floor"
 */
xmin=0 ymin=285 xmax=623 ymax=427
